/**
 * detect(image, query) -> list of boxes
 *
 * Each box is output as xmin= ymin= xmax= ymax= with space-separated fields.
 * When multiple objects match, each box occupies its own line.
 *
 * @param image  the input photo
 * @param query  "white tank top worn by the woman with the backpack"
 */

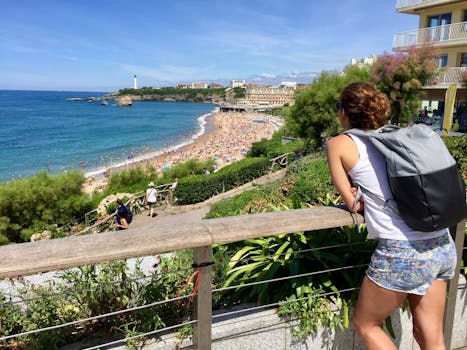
xmin=349 ymin=135 xmax=448 ymax=241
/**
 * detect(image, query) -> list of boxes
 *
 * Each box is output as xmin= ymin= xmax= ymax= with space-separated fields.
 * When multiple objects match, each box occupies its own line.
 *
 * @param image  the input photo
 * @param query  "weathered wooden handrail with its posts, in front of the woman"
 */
xmin=0 ymin=207 xmax=465 ymax=349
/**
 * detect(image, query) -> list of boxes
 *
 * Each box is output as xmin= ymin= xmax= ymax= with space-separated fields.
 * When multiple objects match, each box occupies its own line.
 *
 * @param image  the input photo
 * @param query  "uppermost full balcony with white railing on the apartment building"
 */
xmin=392 ymin=22 xmax=467 ymax=51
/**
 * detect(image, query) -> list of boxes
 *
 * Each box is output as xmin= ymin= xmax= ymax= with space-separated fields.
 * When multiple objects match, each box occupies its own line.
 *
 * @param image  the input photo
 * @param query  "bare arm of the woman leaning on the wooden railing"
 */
xmin=326 ymin=135 xmax=363 ymax=211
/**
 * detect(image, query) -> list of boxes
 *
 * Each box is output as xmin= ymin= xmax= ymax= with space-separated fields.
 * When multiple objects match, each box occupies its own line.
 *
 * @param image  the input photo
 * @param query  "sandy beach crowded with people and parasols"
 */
xmin=83 ymin=112 xmax=283 ymax=193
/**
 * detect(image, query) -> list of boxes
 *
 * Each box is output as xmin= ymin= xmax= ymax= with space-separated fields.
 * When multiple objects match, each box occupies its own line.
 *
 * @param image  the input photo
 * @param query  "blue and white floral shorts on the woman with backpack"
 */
xmin=366 ymin=234 xmax=457 ymax=295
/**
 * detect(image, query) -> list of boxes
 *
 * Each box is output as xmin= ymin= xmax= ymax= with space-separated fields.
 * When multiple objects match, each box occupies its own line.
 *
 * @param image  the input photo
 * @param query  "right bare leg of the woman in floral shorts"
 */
xmin=408 ymin=280 xmax=447 ymax=350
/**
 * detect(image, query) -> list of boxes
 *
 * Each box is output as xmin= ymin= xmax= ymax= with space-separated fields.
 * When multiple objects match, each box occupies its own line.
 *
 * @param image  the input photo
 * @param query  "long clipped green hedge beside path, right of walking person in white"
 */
xmin=174 ymin=158 xmax=270 ymax=204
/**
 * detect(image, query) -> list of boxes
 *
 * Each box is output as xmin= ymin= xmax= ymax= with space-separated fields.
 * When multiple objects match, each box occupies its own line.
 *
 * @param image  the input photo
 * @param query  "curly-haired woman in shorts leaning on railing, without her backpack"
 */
xmin=327 ymin=82 xmax=456 ymax=350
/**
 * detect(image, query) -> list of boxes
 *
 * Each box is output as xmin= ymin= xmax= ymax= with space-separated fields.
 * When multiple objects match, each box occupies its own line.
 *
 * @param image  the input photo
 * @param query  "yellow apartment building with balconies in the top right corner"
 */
xmin=393 ymin=0 xmax=467 ymax=131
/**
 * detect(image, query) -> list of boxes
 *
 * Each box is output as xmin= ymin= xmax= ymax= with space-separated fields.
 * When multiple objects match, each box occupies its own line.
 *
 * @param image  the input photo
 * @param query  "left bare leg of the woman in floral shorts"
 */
xmin=352 ymin=276 xmax=407 ymax=350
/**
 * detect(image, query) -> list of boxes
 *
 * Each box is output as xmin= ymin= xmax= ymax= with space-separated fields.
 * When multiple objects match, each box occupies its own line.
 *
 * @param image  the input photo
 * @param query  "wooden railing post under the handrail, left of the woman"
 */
xmin=193 ymin=246 xmax=212 ymax=350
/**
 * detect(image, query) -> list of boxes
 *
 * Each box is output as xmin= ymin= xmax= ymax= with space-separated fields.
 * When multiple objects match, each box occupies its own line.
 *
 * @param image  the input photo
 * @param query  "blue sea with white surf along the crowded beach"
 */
xmin=0 ymin=90 xmax=218 ymax=183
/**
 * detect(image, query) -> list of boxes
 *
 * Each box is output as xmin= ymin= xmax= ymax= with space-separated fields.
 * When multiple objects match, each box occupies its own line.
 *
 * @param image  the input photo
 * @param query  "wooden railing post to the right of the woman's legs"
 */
xmin=444 ymin=219 xmax=465 ymax=350
